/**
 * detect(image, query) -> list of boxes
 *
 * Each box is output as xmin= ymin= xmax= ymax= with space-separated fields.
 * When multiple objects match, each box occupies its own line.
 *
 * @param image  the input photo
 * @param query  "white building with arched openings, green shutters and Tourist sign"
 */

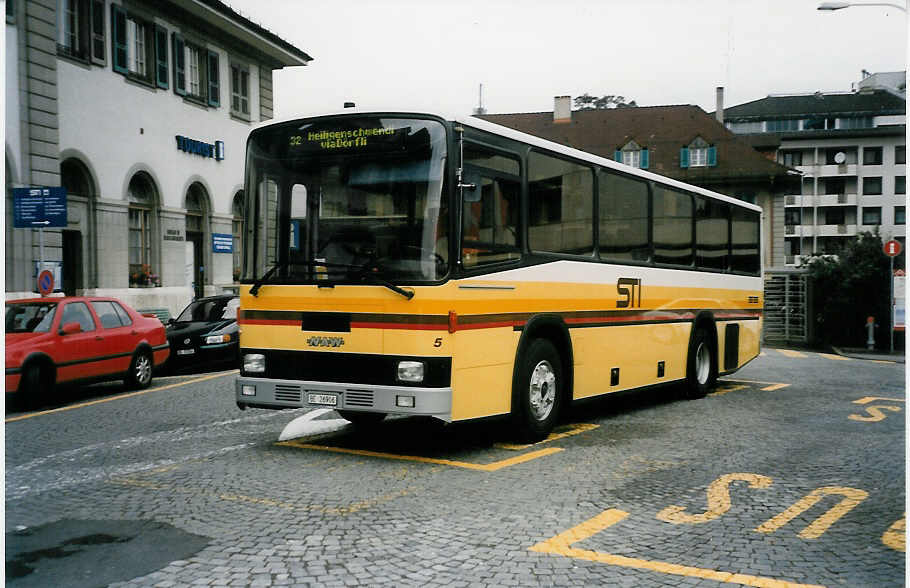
xmin=5 ymin=0 xmax=311 ymax=314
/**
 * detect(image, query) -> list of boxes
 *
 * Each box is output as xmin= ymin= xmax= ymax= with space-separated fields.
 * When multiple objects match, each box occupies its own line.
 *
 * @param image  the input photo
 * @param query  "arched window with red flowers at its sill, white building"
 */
xmin=127 ymin=172 xmax=161 ymax=287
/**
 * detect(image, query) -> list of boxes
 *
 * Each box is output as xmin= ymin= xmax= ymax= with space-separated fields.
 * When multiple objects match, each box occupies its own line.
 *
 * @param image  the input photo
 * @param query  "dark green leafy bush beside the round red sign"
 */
xmin=809 ymin=232 xmax=891 ymax=348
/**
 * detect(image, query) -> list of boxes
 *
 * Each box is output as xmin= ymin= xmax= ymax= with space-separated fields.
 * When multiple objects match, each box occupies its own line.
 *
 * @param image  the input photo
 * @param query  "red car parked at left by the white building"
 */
xmin=6 ymin=296 xmax=170 ymax=401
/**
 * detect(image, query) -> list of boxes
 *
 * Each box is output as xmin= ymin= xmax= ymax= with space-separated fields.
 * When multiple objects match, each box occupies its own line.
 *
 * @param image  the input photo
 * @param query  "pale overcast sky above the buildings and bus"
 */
xmin=225 ymin=0 xmax=908 ymax=118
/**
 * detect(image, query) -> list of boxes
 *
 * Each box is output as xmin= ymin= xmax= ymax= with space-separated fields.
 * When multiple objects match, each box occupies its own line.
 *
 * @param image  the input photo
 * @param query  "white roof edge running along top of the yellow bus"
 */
xmin=254 ymin=108 xmax=762 ymax=212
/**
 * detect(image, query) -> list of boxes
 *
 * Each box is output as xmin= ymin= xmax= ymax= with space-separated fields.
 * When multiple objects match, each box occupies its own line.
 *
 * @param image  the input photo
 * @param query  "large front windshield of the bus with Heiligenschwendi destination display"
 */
xmin=244 ymin=116 xmax=449 ymax=284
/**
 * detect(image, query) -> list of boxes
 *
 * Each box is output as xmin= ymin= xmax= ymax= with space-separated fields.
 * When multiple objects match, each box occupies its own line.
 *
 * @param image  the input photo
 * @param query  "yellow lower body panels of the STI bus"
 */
xmin=240 ymin=276 xmax=762 ymax=420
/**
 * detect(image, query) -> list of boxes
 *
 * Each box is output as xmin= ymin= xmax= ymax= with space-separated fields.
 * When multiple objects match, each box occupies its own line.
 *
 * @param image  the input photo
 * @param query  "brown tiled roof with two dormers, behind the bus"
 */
xmin=479 ymin=105 xmax=789 ymax=184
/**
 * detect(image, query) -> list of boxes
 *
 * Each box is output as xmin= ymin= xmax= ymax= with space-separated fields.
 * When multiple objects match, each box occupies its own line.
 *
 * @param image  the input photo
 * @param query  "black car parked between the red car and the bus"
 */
xmin=167 ymin=294 xmax=240 ymax=371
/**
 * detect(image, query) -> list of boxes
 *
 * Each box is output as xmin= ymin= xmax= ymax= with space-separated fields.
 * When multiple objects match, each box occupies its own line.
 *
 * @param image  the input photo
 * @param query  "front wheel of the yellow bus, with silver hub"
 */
xmin=513 ymin=339 xmax=565 ymax=441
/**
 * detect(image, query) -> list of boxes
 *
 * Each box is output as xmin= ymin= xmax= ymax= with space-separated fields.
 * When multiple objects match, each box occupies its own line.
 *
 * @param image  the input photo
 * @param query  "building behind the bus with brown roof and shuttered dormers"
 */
xmin=478 ymin=96 xmax=799 ymax=267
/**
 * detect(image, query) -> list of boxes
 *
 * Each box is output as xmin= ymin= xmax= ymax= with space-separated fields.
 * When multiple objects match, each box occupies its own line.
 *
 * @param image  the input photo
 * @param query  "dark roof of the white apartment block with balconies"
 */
xmin=724 ymin=90 xmax=907 ymax=121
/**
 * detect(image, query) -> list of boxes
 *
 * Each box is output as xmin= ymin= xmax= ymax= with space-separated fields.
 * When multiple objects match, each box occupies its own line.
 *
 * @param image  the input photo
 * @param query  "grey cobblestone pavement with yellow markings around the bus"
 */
xmin=6 ymin=349 xmax=906 ymax=587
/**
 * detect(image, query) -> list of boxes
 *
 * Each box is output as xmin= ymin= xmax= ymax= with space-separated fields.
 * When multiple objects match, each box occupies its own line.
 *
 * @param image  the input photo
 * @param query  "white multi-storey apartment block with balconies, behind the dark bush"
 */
xmin=723 ymin=72 xmax=906 ymax=267
